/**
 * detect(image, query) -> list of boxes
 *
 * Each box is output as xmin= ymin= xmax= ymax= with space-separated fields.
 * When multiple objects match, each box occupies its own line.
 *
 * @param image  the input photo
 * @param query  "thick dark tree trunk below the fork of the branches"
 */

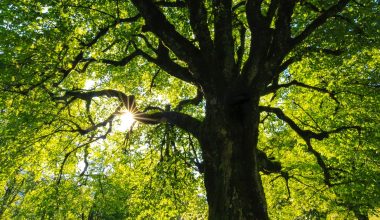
xmin=200 ymin=93 xmax=268 ymax=220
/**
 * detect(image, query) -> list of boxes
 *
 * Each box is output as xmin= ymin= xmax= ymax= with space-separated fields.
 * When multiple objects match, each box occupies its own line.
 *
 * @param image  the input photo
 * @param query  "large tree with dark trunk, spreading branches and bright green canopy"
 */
xmin=0 ymin=0 xmax=380 ymax=220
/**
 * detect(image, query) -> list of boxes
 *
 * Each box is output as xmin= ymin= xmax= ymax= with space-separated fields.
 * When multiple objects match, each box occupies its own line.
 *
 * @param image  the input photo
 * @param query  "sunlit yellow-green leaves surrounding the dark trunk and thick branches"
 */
xmin=0 ymin=0 xmax=380 ymax=219
